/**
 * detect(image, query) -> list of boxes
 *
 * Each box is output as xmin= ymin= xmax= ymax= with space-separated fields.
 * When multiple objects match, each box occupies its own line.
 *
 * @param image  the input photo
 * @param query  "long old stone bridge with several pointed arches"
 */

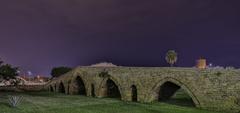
xmin=46 ymin=67 xmax=240 ymax=113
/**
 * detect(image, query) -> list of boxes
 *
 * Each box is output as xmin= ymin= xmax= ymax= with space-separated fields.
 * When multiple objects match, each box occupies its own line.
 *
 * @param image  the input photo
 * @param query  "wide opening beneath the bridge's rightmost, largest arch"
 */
xmin=158 ymin=82 xmax=195 ymax=107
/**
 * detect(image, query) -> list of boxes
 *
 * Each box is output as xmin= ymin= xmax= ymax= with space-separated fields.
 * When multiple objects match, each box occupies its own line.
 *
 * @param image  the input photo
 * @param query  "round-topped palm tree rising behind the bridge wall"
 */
xmin=165 ymin=50 xmax=178 ymax=67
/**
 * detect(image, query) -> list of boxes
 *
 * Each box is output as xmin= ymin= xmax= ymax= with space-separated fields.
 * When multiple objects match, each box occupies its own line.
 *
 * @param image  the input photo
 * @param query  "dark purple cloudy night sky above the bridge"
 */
xmin=0 ymin=0 xmax=240 ymax=75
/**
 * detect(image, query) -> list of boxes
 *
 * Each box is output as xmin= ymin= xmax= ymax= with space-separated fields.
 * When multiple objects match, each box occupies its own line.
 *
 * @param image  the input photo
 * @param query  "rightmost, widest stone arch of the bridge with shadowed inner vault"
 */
xmin=150 ymin=78 xmax=200 ymax=107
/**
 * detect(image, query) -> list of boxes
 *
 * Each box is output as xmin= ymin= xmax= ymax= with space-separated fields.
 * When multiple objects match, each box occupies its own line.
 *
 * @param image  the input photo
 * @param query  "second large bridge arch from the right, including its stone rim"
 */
xmin=98 ymin=76 xmax=123 ymax=100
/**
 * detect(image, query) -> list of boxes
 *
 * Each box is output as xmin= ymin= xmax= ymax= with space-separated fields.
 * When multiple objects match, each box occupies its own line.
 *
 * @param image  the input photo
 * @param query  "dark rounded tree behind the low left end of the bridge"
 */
xmin=51 ymin=66 xmax=72 ymax=77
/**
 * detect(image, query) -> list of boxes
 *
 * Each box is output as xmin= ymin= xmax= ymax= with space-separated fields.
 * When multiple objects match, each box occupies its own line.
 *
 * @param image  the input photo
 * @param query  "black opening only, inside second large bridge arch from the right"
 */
xmin=107 ymin=79 xmax=121 ymax=99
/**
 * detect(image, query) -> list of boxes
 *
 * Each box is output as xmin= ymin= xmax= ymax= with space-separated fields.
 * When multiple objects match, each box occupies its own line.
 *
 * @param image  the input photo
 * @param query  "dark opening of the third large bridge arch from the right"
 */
xmin=75 ymin=76 xmax=87 ymax=95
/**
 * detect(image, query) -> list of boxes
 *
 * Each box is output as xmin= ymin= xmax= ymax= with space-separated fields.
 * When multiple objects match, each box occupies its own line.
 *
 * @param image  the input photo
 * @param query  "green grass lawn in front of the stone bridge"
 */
xmin=0 ymin=92 xmax=226 ymax=113
